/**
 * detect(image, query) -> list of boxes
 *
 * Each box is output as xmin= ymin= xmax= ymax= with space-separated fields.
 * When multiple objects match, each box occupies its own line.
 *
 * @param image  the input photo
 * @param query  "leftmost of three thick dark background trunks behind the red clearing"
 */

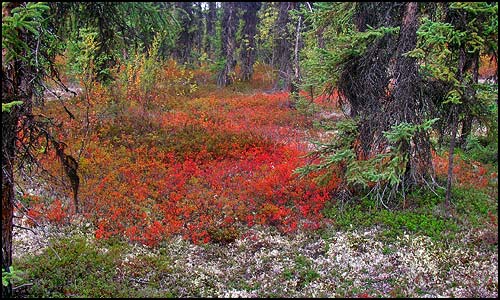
xmin=217 ymin=2 xmax=237 ymax=87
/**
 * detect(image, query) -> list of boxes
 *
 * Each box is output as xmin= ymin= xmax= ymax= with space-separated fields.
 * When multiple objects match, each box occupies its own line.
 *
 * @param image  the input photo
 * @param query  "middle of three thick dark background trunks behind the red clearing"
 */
xmin=240 ymin=2 xmax=261 ymax=81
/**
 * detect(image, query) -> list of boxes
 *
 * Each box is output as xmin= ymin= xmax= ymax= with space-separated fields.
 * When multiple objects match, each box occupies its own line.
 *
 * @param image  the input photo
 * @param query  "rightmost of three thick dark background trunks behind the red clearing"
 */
xmin=273 ymin=2 xmax=297 ymax=91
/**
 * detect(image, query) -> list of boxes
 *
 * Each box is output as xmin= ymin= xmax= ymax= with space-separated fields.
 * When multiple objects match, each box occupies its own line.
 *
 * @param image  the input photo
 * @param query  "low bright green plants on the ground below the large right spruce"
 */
xmin=323 ymin=188 xmax=498 ymax=241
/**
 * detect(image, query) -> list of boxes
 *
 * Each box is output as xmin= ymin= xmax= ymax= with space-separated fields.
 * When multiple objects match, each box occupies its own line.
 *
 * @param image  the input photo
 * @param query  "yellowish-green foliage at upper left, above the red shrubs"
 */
xmin=54 ymin=2 xmax=179 ymax=83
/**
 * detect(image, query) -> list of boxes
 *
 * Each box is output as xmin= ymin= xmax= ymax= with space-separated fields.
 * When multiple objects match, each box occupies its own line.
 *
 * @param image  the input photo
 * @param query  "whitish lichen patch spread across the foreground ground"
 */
xmin=9 ymin=220 xmax=498 ymax=298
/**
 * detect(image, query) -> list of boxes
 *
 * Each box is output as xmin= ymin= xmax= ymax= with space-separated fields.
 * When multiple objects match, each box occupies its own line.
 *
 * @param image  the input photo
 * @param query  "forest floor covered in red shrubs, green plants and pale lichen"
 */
xmin=9 ymin=64 xmax=498 ymax=298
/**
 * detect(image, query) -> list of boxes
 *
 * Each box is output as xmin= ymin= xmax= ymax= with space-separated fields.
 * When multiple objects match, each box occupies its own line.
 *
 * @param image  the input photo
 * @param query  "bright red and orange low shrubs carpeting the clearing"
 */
xmin=20 ymin=63 xmax=492 ymax=246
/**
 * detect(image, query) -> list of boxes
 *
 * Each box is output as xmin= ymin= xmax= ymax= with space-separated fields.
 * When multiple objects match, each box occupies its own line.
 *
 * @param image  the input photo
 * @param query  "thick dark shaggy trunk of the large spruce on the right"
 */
xmin=338 ymin=2 xmax=434 ymax=199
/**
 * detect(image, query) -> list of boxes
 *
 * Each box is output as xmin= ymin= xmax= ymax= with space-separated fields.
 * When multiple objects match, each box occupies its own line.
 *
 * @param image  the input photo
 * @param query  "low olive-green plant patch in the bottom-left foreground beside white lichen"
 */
xmin=14 ymin=235 xmax=181 ymax=298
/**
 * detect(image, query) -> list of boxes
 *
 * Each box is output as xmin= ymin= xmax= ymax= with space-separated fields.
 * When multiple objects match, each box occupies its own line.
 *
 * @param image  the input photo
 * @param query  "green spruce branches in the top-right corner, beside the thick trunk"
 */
xmin=406 ymin=2 xmax=498 ymax=146
